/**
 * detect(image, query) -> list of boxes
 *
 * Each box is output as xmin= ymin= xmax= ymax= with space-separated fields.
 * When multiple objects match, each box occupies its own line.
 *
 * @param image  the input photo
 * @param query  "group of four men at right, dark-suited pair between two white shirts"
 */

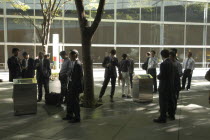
xmin=144 ymin=49 xmax=195 ymax=123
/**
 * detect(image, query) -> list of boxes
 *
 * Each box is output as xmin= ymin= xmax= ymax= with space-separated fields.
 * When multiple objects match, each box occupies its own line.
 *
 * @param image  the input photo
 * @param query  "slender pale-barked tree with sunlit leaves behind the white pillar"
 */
xmin=6 ymin=0 xmax=71 ymax=53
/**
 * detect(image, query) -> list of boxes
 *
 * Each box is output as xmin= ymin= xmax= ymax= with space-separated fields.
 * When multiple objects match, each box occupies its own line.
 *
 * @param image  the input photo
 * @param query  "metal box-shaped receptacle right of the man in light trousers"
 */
xmin=133 ymin=74 xmax=153 ymax=102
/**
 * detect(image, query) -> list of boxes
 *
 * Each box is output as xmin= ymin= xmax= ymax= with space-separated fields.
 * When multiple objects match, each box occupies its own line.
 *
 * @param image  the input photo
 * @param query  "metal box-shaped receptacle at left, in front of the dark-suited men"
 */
xmin=13 ymin=78 xmax=37 ymax=115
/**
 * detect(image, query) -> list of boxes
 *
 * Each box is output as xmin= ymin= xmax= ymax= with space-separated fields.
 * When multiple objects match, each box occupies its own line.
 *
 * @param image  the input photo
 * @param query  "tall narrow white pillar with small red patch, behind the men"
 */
xmin=53 ymin=34 xmax=60 ymax=71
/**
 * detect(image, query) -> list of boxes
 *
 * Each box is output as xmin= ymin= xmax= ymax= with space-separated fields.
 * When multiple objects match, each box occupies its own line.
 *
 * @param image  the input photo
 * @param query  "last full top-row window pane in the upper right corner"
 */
xmin=187 ymin=2 xmax=204 ymax=22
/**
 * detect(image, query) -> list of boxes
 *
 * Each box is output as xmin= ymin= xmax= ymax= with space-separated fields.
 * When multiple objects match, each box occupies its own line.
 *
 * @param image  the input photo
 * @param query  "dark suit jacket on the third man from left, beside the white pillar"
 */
xmin=34 ymin=59 xmax=51 ymax=81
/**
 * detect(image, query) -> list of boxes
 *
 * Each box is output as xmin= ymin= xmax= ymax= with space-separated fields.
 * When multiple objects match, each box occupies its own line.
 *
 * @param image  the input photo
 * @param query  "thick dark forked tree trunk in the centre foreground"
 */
xmin=75 ymin=0 xmax=105 ymax=107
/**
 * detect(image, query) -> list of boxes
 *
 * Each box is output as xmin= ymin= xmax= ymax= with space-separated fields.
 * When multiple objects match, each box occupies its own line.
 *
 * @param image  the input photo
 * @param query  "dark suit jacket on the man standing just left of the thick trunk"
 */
xmin=68 ymin=60 xmax=84 ymax=93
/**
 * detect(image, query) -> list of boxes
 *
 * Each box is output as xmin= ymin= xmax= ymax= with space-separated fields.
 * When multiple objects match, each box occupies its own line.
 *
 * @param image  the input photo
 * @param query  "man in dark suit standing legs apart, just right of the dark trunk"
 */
xmin=98 ymin=49 xmax=118 ymax=102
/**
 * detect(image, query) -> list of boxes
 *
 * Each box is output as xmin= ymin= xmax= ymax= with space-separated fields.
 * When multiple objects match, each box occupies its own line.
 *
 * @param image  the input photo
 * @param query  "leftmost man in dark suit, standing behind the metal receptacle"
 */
xmin=7 ymin=48 xmax=22 ymax=82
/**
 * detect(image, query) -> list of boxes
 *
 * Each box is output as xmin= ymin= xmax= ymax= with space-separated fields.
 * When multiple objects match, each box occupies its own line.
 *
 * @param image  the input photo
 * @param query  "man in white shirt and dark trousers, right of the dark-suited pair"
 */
xmin=182 ymin=52 xmax=195 ymax=90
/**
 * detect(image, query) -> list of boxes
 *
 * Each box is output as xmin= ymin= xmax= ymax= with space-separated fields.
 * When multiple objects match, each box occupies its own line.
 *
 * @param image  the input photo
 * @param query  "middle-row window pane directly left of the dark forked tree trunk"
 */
xmin=64 ymin=20 xmax=81 ymax=43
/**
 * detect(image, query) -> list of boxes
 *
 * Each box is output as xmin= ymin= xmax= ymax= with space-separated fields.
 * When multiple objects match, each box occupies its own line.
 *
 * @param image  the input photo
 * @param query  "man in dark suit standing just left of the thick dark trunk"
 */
xmin=63 ymin=49 xmax=83 ymax=123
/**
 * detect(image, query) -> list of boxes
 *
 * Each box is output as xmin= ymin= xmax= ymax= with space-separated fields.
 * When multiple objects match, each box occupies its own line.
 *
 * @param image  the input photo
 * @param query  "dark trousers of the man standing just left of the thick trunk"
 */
xmin=66 ymin=82 xmax=80 ymax=120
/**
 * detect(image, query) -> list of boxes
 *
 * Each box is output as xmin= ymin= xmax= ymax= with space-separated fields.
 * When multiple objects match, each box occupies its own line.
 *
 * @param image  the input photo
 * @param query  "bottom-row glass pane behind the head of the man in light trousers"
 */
xmin=117 ymin=46 xmax=139 ymax=68
